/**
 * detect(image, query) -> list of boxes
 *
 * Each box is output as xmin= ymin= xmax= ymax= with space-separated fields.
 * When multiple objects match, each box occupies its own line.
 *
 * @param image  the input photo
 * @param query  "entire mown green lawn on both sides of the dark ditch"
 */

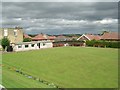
xmin=2 ymin=47 xmax=118 ymax=88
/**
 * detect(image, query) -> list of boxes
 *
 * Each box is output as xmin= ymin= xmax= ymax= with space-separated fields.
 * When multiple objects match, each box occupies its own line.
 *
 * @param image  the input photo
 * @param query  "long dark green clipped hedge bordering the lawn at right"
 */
xmin=86 ymin=40 xmax=120 ymax=48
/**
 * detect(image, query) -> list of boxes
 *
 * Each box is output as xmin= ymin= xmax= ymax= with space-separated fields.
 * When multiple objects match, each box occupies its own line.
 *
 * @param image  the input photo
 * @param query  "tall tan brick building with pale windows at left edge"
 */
xmin=0 ymin=27 xmax=23 ymax=43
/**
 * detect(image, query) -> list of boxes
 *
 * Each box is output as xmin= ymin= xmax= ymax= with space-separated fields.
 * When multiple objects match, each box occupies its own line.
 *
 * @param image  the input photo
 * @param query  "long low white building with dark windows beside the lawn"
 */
xmin=12 ymin=41 xmax=53 ymax=51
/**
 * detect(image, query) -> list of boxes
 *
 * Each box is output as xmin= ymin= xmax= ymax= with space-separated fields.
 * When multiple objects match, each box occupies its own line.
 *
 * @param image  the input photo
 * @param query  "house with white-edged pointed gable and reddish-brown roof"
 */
xmin=77 ymin=34 xmax=101 ymax=41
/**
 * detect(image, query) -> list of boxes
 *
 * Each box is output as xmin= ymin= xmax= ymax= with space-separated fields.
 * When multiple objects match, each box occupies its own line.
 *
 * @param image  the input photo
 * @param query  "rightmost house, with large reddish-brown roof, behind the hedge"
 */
xmin=101 ymin=32 xmax=120 ymax=41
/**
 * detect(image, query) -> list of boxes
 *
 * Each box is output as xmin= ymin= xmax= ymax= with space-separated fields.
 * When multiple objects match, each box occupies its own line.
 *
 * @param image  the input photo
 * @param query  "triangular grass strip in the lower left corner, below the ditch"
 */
xmin=2 ymin=68 xmax=53 ymax=88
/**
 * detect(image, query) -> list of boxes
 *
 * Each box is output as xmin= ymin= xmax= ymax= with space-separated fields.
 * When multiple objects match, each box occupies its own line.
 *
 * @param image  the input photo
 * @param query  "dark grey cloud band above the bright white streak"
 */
xmin=3 ymin=2 xmax=118 ymax=19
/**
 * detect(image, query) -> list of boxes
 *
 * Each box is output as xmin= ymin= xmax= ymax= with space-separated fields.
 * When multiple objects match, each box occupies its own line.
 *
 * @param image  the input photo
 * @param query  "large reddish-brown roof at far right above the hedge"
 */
xmin=101 ymin=32 xmax=120 ymax=40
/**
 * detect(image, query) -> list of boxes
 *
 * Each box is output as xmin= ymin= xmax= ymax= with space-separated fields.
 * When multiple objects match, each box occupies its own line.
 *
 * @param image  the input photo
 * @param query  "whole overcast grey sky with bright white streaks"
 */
xmin=2 ymin=0 xmax=118 ymax=34
